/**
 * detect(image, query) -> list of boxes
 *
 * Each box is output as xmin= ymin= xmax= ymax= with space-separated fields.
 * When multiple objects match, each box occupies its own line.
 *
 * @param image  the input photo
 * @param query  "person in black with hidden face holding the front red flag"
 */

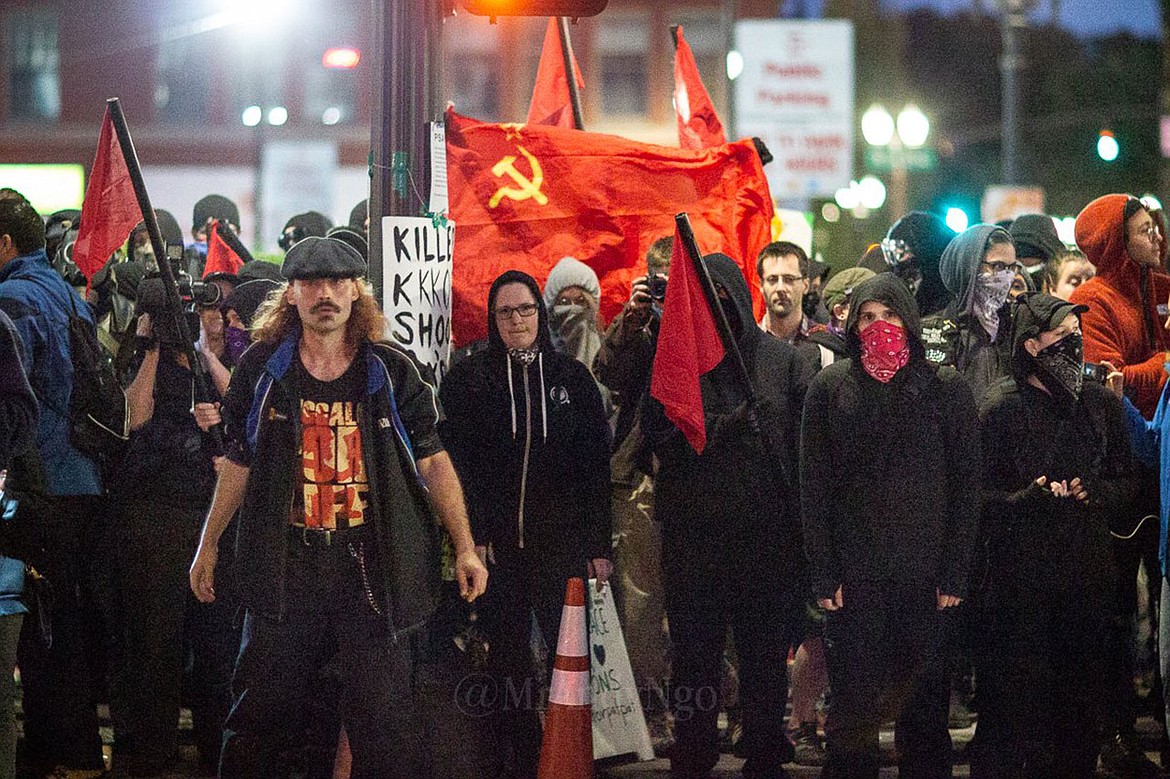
xmin=641 ymin=254 xmax=812 ymax=778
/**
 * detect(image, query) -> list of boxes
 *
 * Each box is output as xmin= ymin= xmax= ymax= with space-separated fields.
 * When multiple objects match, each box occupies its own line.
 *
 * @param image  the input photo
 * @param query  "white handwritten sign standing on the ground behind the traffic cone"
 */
xmin=589 ymin=579 xmax=654 ymax=760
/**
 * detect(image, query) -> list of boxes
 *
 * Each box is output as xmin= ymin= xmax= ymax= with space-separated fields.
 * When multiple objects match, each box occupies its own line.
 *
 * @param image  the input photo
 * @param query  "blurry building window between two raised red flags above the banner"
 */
xmin=593 ymin=12 xmax=649 ymax=117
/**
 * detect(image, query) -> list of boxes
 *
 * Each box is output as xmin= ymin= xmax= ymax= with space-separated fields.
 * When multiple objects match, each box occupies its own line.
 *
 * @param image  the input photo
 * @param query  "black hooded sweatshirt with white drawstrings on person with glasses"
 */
xmin=439 ymin=270 xmax=612 ymax=559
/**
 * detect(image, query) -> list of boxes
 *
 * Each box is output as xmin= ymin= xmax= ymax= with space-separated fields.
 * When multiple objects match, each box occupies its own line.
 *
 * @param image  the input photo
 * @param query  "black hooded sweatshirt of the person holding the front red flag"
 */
xmin=641 ymin=254 xmax=812 ymax=601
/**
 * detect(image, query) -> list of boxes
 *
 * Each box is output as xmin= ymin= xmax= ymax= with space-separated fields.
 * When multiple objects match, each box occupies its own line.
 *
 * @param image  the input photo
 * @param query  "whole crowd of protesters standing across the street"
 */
xmin=0 ymin=178 xmax=1170 ymax=779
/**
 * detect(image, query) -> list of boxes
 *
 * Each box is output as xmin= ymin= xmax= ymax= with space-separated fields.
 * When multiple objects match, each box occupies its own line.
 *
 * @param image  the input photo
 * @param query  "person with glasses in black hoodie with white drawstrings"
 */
xmin=440 ymin=270 xmax=613 ymax=777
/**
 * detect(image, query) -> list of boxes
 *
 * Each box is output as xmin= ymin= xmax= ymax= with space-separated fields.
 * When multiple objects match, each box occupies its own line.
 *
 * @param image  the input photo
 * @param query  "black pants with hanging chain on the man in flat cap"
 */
xmin=220 ymin=533 xmax=428 ymax=779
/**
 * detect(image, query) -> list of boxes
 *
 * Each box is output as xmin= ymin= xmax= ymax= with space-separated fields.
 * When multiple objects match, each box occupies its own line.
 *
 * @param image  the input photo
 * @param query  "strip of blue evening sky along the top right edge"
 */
xmin=787 ymin=0 xmax=1162 ymax=37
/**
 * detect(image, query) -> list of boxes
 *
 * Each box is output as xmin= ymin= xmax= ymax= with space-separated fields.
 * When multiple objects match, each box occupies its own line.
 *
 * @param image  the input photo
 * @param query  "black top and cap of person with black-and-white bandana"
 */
xmin=979 ymin=292 xmax=1137 ymax=591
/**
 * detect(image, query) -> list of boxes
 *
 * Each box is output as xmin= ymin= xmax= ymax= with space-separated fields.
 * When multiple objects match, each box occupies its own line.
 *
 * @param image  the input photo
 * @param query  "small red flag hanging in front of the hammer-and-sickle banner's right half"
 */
xmin=651 ymin=224 xmax=723 ymax=454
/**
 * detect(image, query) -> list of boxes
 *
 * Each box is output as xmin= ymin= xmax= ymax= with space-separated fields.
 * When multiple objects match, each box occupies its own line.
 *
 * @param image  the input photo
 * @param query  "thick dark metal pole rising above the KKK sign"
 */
xmin=370 ymin=0 xmax=442 ymax=297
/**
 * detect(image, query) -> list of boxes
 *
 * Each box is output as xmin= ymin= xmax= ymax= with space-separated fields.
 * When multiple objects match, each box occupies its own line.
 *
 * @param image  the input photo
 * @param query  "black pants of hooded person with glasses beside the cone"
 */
xmin=482 ymin=549 xmax=587 ymax=777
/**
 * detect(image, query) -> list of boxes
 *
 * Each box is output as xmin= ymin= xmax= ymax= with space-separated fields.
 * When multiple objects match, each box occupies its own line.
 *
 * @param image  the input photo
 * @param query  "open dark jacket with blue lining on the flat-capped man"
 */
xmin=223 ymin=333 xmax=442 ymax=635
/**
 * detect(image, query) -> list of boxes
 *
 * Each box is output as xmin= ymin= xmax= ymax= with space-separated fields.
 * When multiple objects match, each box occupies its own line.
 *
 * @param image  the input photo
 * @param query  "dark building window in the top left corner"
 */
xmin=6 ymin=9 xmax=61 ymax=119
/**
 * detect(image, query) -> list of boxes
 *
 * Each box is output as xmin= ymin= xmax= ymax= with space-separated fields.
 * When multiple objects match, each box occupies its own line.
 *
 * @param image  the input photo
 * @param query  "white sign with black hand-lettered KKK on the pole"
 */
xmin=381 ymin=216 xmax=455 ymax=381
